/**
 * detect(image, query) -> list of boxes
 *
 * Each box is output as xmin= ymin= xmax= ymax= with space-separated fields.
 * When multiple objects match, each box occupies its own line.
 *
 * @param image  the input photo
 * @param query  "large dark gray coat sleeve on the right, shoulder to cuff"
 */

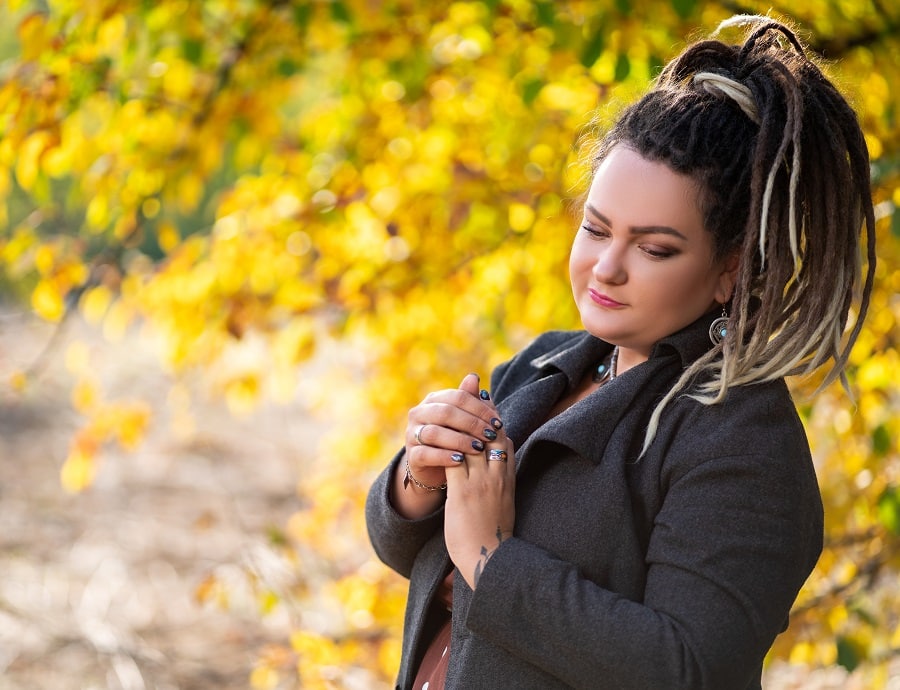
xmin=466 ymin=390 xmax=822 ymax=690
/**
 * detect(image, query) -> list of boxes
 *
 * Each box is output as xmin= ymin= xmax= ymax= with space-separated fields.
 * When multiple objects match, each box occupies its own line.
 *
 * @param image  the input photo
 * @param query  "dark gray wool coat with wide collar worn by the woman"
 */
xmin=366 ymin=315 xmax=823 ymax=690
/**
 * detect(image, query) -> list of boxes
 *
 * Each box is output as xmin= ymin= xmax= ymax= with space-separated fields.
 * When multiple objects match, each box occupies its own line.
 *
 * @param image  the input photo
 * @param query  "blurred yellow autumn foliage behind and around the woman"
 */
xmin=0 ymin=0 xmax=900 ymax=688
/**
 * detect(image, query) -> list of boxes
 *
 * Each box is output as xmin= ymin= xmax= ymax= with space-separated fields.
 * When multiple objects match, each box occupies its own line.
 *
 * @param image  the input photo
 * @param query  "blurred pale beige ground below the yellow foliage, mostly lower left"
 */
xmin=0 ymin=310 xmax=900 ymax=690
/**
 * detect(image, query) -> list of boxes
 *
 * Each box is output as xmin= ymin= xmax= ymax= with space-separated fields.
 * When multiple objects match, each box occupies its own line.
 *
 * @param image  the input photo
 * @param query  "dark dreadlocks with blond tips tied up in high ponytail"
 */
xmin=591 ymin=16 xmax=875 ymax=455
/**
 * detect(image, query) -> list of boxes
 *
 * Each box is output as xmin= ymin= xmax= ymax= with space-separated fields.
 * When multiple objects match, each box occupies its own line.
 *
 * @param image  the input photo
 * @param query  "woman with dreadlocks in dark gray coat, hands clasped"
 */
xmin=366 ymin=17 xmax=874 ymax=690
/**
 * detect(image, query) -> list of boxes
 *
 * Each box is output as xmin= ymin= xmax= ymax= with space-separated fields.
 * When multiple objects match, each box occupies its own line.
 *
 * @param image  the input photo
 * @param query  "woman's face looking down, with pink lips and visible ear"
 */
xmin=569 ymin=145 xmax=737 ymax=365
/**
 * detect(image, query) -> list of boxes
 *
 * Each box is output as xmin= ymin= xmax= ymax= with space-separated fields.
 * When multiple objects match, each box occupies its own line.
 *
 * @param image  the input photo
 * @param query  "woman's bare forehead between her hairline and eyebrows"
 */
xmin=586 ymin=145 xmax=705 ymax=234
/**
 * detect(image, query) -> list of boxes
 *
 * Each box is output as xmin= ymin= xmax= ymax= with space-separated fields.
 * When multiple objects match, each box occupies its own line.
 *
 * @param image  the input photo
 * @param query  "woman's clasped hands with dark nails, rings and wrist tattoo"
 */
xmin=399 ymin=374 xmax=516 ymax=589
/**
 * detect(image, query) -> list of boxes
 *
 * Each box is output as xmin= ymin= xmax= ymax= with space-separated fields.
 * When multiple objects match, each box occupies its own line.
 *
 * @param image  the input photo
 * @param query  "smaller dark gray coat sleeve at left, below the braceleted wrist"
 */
xmin=366 ymin=449 xmax=444 ymax=578
